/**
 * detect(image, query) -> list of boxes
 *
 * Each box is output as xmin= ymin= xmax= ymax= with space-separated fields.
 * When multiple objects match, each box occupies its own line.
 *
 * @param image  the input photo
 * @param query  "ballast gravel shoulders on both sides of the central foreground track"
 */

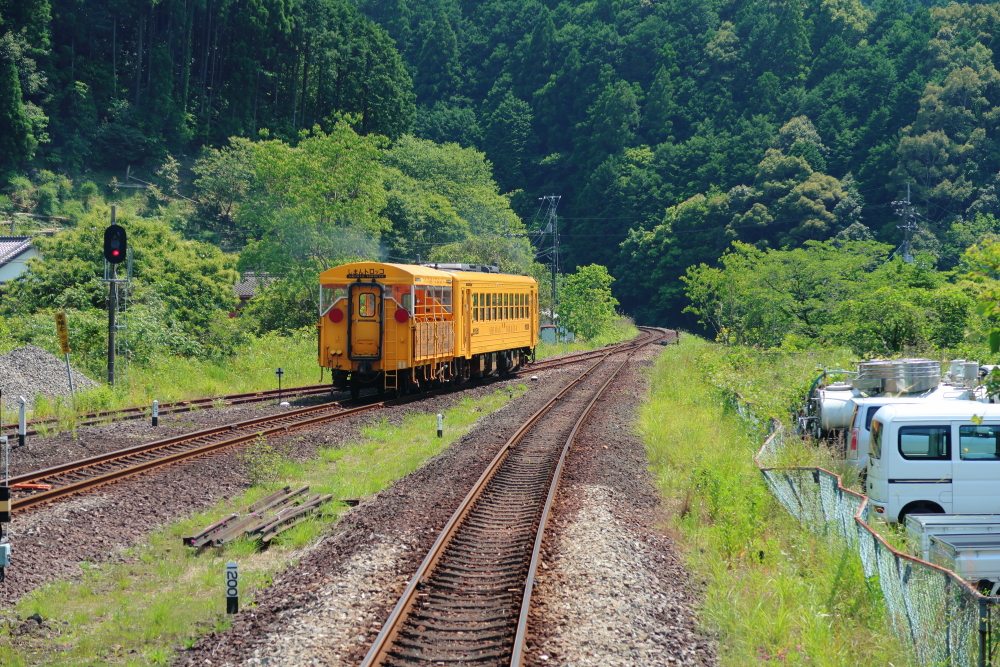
xmin=175 ymin=332 xmax=717 ymax=667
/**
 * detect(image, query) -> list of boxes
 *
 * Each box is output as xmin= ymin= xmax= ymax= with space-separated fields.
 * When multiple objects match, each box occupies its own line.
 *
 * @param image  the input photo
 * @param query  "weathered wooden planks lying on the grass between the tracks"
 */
xmin=182 ymin=486 xmax=333 ymax=549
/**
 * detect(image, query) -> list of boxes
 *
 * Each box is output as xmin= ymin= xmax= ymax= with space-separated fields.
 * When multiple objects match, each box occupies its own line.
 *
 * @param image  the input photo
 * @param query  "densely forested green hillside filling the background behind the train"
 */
xmin=0 ymin=0 xmax=1000 ymax=358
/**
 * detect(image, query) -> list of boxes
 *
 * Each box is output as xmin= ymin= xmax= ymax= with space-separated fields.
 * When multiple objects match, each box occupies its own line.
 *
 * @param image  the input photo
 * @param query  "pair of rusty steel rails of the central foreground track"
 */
xmin=361 ymin=329 xmax=665 ymax=667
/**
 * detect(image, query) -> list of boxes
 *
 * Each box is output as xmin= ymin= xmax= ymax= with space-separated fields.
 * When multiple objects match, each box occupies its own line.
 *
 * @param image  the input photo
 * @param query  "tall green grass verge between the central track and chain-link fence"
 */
xmin=639 ymin=336 xmax=912 ymax=667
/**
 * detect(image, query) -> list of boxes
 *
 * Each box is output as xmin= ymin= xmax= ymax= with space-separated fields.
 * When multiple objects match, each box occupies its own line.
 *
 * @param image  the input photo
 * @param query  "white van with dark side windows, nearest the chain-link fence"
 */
xmin=866 ymin=401 xmax=1000 ymax=522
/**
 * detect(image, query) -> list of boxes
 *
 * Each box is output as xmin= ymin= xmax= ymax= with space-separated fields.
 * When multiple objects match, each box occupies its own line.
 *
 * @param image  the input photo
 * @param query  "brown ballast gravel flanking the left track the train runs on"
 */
xmin=0 ymin=378 xmax=553 ymax=608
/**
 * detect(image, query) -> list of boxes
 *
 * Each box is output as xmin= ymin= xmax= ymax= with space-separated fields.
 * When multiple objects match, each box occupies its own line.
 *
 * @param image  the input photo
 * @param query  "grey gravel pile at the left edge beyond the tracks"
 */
xmin=0 ymin=345 xmax=97 ymax=410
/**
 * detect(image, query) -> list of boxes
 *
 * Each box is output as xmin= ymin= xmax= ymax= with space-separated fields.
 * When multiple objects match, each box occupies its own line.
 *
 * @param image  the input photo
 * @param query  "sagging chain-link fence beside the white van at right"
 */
xmin=755 ymin=424 xmax=1000 ymax=667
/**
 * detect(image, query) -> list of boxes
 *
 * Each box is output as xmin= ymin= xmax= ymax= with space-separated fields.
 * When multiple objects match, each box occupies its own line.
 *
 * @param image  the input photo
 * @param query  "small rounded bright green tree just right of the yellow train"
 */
xmin=556 ymin=264 xmax=618 ymax=340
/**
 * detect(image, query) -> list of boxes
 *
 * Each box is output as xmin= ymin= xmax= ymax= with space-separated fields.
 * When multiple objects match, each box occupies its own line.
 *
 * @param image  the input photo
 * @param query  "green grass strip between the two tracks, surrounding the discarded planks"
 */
xmin=0 ymin=384 xmax=527 ymax=667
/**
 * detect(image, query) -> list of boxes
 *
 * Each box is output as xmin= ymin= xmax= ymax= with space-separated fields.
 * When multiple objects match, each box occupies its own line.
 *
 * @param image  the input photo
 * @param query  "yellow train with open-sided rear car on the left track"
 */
xmin=318 ymin=262 xmax=538 ymax=396
